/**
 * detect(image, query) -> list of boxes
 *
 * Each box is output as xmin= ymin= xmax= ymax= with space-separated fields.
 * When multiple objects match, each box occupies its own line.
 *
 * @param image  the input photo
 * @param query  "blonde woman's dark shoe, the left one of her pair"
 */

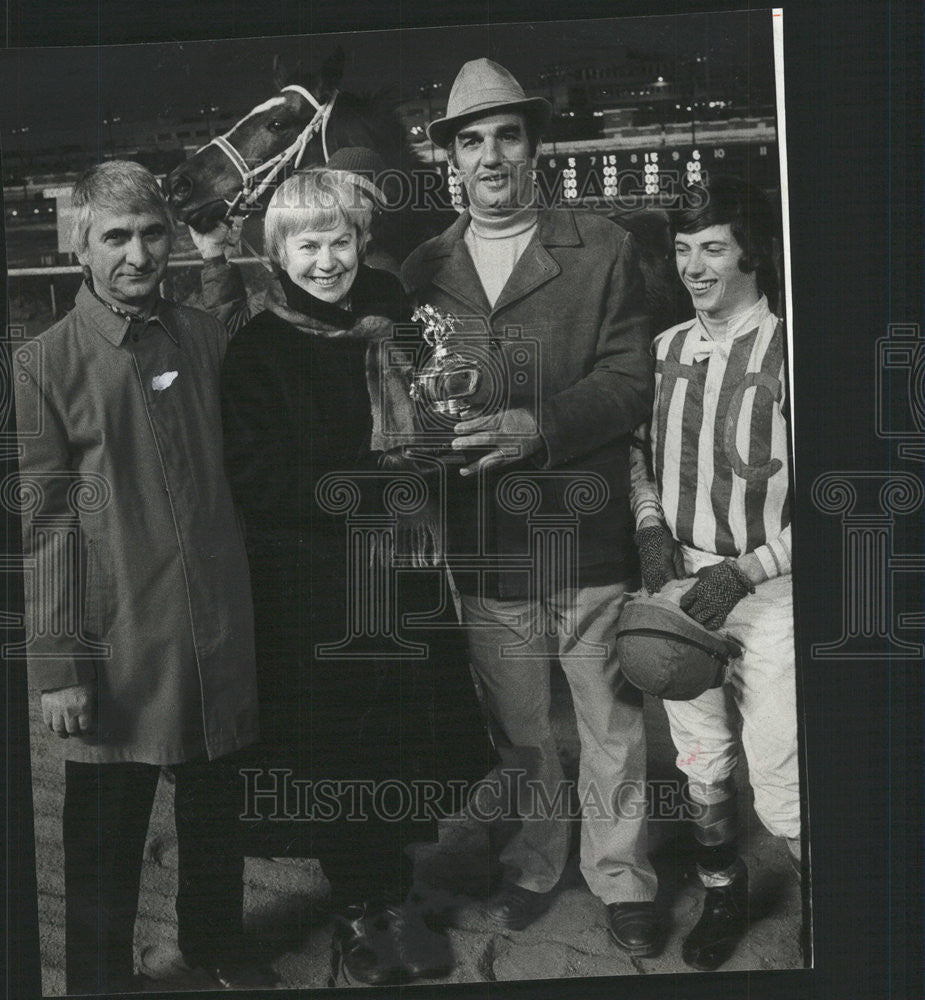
xmin=330 ymin=903 xmax=404 ymax=986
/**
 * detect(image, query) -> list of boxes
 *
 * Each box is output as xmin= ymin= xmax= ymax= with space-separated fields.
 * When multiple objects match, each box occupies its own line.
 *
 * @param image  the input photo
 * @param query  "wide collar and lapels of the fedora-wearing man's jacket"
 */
xmin=414 ymin=209 xmax=582 ymax=314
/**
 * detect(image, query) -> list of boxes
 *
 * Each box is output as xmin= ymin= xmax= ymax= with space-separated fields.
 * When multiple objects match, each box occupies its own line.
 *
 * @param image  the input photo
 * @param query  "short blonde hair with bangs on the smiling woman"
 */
xmin=263 ymin=167 xmax=375 ymax=267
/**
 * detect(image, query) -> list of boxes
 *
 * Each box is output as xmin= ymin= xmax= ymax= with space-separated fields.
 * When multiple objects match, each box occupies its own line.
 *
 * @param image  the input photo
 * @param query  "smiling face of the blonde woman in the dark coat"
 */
xmin=282 ymin=221 xmax=360 ymax=303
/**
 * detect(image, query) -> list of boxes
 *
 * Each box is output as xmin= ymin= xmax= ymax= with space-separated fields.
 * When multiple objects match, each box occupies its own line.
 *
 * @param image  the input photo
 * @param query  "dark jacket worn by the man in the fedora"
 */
xmin=402 ymin=203 xmax=653 ymax=598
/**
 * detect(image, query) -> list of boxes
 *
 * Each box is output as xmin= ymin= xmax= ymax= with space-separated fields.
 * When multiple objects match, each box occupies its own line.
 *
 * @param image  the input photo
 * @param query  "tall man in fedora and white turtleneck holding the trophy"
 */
xmin=402 ymin=59 xmax=661 ymax=956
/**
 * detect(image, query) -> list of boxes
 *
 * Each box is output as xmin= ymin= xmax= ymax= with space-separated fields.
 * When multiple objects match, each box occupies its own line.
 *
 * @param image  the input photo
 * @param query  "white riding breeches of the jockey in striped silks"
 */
xmin=664 ymin=568 xmax=800 ymax=841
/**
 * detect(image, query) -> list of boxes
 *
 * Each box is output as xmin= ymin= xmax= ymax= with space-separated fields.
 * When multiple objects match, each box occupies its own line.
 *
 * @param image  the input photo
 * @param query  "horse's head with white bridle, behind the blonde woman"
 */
xmin=164 ymin=48 xmax=346 ymax=232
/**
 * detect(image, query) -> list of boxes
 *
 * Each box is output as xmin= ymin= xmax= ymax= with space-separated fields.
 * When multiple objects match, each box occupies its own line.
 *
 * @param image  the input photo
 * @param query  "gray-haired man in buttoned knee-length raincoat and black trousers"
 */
xmin=14 ymin=161 xmax=268 ymax=994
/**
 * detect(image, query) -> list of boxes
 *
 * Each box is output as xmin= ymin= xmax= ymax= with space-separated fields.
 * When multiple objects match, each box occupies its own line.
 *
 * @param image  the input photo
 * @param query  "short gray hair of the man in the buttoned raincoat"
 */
xmin=71 ymin=160 xmax=176 ymax=254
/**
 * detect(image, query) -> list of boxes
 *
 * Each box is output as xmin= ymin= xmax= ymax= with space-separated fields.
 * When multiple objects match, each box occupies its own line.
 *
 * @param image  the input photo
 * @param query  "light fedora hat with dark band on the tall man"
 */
xmin=427 ymin=59 xmax=552 ymax=147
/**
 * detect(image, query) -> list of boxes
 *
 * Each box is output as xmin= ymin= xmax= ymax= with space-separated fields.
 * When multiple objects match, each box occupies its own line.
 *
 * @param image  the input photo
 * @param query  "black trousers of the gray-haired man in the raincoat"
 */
xmin=63 ymin=755 xmax=244 ymax=993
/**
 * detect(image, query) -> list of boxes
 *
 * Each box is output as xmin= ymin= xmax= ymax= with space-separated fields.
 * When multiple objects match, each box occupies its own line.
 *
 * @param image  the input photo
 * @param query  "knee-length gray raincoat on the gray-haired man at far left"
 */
xmin=13 ymin=285 xmax=257 ymax=764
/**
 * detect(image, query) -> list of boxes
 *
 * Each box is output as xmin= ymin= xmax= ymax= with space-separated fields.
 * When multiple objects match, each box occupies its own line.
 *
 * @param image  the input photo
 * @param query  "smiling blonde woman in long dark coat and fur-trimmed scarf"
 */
xmin=223 ymin=160 xmax=489 ymax=984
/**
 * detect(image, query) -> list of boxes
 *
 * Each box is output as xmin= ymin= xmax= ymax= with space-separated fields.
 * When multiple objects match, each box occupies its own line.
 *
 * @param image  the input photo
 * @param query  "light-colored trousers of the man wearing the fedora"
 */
xmin=462 ymin=584 xmax=656 ymax=903
